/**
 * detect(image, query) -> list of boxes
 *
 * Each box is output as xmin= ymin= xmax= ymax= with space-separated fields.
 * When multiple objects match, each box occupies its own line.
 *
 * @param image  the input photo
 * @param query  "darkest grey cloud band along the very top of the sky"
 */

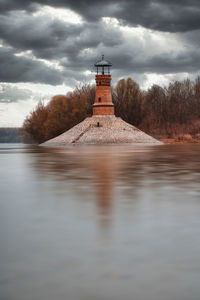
xmin=0 ymin=0 xmax=200 ymax=32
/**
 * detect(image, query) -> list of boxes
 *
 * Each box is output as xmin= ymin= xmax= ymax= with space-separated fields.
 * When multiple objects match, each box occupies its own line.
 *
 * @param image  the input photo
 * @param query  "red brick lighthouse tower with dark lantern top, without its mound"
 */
xmin=93 ymin=55 xmax=115 ymax=116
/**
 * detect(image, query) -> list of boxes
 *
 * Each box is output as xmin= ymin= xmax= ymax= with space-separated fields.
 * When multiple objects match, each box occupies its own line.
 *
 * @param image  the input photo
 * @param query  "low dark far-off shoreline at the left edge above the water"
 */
xmin=0 ymin=128 xmax=23 ymax=143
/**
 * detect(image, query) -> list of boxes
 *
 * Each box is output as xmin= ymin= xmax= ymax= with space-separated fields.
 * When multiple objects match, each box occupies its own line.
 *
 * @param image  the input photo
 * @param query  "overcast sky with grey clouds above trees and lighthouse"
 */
xmin=0 ymin=0 xmax=200 ymax=127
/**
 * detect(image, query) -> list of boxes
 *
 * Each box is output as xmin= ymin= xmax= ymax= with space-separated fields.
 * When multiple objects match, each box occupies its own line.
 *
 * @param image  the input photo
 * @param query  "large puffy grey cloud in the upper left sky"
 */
xmin=0 ymin=11 xmax=122 ymax=59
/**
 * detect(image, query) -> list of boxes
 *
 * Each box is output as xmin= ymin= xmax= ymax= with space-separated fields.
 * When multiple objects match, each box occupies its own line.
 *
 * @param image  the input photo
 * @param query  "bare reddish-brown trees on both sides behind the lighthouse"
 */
xmin=23 ymin=78 xmax=200 ymax=143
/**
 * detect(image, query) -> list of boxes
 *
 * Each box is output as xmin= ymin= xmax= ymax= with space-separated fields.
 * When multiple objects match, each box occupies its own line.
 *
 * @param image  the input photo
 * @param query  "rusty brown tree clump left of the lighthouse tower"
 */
xmin=23 ymin=86 xmax=95 ymax=143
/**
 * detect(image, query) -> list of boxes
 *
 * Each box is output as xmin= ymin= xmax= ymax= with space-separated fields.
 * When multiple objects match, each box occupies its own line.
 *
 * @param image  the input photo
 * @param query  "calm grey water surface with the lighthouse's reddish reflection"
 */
xmin=0 ymin=144 xmax=200 ymax=300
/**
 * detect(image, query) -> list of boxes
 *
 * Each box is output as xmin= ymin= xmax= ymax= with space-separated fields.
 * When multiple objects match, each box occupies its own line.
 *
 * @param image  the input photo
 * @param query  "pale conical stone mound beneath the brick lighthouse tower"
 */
xmin=41 ymin=116 xmax=162 ymax=146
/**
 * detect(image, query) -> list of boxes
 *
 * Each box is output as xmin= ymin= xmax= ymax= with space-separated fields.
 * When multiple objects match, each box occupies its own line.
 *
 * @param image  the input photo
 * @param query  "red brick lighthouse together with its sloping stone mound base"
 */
xmin=41 ymin=55 xmax=162 ymax=147
